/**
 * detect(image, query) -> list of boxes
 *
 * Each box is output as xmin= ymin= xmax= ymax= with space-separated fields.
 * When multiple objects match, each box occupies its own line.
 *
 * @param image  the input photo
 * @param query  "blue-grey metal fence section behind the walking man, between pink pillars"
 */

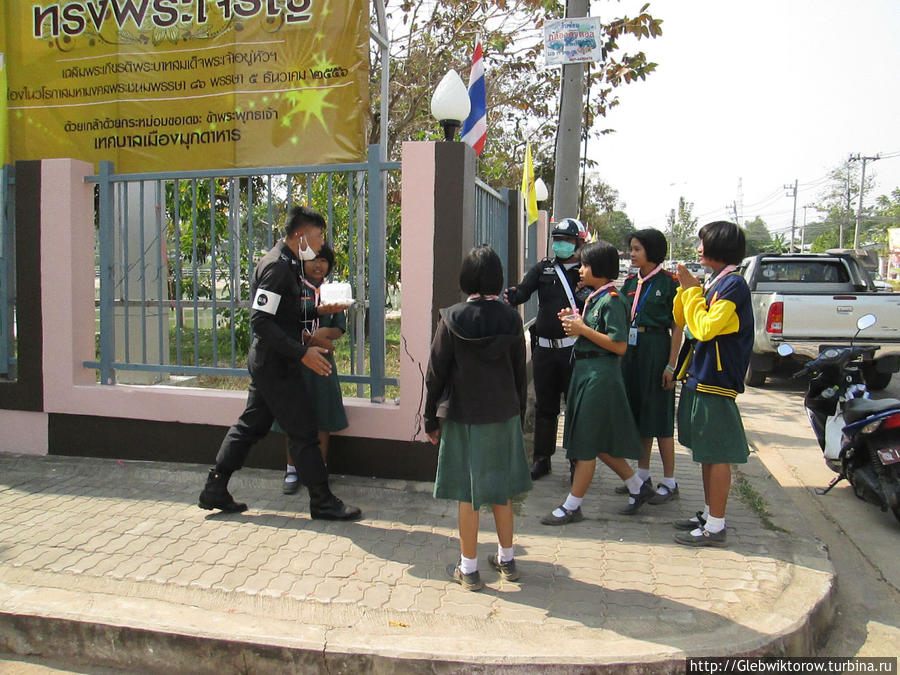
xmin=85 ymin=146 xmax=400 ymax=401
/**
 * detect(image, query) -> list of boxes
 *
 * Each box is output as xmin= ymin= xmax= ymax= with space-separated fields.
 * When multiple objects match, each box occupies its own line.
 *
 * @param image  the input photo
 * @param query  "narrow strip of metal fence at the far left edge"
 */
xmin=0 ymin=165 xmax=16 ymax=380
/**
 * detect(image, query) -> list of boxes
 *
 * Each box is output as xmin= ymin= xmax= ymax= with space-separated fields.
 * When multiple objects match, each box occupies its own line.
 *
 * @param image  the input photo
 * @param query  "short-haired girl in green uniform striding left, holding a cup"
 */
xmin=541 ymin=241 xmax=654 ymax=525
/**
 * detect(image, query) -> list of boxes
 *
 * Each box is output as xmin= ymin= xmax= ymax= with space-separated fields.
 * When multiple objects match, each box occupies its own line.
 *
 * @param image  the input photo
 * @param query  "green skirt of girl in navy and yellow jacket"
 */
xmin=678 ymin=386 xmax=750 ymax=464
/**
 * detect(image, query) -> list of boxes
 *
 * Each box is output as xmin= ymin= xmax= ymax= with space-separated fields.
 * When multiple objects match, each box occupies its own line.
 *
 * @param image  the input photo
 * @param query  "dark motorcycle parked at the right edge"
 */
xmin=778 ymin=314 xmax=900 ymax=521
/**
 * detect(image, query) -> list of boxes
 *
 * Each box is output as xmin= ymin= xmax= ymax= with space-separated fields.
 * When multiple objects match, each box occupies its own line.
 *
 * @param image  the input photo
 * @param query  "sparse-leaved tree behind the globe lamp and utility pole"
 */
xmin=369 ymin=0 xmax=662 ymax=187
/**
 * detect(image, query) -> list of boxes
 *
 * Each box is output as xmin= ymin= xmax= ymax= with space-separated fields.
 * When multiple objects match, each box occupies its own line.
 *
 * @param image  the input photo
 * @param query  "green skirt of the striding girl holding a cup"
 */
xmin=563 ymin=356 xmax=641 ymax=460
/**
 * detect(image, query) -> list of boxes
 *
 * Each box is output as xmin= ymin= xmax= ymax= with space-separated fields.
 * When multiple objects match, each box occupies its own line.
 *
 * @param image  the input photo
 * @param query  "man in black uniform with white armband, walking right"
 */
xmin=199 ymin=206 xmax=361 ymax=520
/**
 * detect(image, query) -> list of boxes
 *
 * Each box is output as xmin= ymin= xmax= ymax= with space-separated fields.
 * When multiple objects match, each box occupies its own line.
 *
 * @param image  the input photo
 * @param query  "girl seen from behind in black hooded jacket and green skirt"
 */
xmin=424 ymin=246 xmax=531 ymax=591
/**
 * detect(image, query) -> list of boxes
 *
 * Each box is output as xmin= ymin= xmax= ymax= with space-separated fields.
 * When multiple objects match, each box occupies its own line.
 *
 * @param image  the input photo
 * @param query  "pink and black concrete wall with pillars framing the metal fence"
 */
xmin=0 ymin=143 xmax=486 ymax=479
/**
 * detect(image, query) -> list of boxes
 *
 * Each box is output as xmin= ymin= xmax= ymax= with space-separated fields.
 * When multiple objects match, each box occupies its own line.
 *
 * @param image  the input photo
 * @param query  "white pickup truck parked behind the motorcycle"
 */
xmin=740 ymin=253 xmax=900 ymax=390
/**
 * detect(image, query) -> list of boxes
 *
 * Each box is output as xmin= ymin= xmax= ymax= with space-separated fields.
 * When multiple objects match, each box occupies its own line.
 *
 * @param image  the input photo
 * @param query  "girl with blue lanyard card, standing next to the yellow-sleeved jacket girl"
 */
xmin=621 ymin=229 xmax=682 ymax=504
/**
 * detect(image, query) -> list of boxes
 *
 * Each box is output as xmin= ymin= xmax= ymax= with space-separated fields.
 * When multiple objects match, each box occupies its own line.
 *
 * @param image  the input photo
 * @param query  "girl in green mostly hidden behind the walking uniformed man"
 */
xmin=280 ymin=244 xmax=348 ymax=494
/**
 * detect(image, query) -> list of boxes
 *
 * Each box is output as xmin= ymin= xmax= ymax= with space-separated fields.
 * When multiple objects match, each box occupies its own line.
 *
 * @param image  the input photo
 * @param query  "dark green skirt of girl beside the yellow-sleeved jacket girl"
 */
xmin=622 ymin=333 xmax=675 ymax=438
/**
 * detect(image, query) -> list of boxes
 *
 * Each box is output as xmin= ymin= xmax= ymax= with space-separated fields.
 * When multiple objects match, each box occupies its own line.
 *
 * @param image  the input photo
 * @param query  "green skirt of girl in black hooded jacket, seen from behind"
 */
xmin=434 ymin=415 xmax=531 ymax=509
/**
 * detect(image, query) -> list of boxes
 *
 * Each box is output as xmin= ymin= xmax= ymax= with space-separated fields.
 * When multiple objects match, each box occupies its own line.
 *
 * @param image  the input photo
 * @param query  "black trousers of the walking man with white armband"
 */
xmin=216 ymin=352 xmax=328 ymax=486
